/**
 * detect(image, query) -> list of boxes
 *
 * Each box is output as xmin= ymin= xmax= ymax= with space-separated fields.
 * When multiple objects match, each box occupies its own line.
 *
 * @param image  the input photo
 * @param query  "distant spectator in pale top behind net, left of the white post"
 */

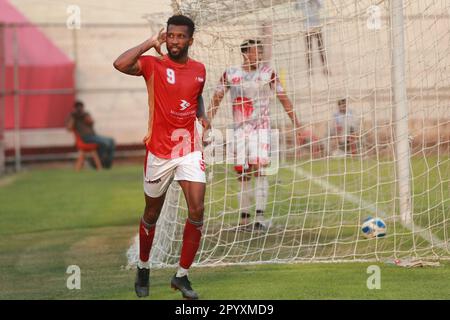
xmin=332 ymin=98 xmax=358 ymax=154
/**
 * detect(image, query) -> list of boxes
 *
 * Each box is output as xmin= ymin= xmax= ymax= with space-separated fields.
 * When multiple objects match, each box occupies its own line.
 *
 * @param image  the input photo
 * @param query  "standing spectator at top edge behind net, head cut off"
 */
xmin=296 ymin=0 xmax=329 ymax=76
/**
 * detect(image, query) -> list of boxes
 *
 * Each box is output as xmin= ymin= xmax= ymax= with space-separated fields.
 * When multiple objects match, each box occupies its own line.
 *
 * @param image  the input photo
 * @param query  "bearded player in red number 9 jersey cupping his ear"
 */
xmin=114 ymin=15 xmax=209 ymax=299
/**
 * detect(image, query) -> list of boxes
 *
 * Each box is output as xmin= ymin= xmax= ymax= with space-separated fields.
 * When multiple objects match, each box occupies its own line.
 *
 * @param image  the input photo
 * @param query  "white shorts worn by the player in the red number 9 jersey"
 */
xmin=144 ymin=151 xmax=206 ymax=198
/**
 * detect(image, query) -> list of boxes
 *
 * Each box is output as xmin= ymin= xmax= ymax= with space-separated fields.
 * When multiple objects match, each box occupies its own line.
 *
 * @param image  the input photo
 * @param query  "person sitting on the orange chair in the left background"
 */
xmin=67 ymin=101 xmax=115 ymax=169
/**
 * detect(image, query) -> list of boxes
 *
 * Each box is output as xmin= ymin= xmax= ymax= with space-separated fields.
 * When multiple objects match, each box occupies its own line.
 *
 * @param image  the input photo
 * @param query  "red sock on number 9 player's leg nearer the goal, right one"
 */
xmin=180 ymin=219 xmax=203 ymax=269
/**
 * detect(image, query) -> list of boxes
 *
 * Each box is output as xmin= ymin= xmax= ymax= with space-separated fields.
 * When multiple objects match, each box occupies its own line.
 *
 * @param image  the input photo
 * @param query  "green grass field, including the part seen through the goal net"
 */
xmin=0 ymin=157 xmax=450 ymax=299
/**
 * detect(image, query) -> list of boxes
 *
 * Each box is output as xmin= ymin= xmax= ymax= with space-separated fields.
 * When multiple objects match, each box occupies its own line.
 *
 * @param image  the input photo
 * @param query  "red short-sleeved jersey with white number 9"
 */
xmin=139 ymin=55 xmax=206 ymax=159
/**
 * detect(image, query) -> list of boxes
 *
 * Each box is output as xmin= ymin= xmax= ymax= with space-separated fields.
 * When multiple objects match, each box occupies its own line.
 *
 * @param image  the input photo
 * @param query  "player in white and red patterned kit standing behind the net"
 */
xmin=208 ymin=39 xmax=312 ymax=231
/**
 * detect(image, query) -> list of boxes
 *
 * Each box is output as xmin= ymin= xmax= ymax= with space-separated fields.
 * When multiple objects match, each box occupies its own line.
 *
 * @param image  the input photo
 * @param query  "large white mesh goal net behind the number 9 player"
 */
xmin=125 ymin=0 xmax=450 ymax=266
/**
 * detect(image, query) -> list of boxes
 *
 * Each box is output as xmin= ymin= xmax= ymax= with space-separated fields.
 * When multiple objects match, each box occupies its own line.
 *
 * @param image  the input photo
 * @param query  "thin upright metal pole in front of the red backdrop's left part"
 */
xmin=13 ymin=26 xmax=22 ymax=172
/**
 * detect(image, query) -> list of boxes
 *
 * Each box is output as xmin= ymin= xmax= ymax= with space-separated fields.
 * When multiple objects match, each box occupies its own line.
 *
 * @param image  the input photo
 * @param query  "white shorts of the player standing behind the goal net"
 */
xmin=235 ymin=129 xmax=270 ymax=168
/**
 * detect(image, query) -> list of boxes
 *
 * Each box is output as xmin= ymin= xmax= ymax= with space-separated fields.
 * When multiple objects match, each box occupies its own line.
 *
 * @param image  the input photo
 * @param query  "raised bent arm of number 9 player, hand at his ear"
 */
xmin=114 ymin=29 xmax=166 ymax=76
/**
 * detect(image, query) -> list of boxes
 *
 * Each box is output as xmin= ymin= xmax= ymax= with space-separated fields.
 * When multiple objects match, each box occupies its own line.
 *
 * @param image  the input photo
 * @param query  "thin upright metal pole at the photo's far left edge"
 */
xmin=0 ymin=24 xmax=6 ymax=176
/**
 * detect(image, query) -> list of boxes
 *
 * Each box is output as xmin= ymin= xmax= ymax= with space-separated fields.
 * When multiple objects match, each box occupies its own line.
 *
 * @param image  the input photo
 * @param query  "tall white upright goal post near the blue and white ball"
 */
xmin=391 ymin=0 xmax=411 ymax=224
